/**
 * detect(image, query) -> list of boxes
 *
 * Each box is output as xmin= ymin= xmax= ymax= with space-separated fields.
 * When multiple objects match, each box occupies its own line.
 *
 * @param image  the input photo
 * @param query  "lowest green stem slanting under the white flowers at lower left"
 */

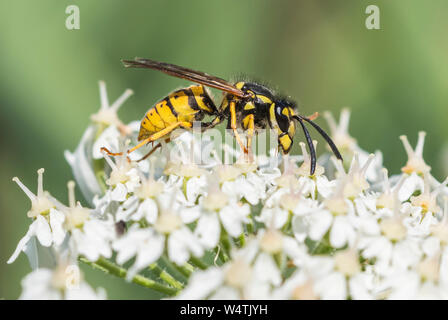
xmin=79 ymin=257 xmax=179 ymax=296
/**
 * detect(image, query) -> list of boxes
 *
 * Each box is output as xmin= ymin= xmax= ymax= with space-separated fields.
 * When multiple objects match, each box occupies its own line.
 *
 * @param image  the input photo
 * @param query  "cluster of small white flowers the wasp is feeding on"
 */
xmin=8 ymin=82 xmax=448 ymax=299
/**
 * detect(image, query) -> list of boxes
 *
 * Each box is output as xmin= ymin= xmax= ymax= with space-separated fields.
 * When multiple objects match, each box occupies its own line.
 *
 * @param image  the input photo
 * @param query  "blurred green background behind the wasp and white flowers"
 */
xmin=0 ymin=0 xmax=448 ymax=299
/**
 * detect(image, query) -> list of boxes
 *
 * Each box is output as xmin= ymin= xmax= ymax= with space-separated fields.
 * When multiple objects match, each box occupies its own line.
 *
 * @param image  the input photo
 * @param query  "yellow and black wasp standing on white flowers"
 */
xmin=102 ymin=58 xmax=342 ymax=175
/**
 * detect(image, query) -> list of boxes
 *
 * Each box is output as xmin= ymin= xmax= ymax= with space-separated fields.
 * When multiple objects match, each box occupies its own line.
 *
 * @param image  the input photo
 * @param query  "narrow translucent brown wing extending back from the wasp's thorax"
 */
xmin=122 ymin=58 xmax=247 ymax=98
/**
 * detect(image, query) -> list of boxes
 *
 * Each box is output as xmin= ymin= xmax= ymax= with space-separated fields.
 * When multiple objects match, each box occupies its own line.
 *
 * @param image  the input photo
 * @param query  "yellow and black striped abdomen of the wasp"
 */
xmin=138 ymin=85 xmax=218 ymax=141
